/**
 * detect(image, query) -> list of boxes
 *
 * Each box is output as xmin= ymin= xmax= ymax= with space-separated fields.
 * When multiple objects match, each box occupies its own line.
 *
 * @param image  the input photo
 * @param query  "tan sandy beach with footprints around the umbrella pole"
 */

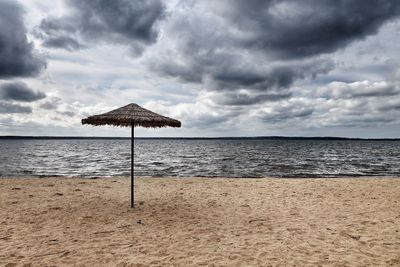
xmin=0 ymin=177 xmax=400 ymax=266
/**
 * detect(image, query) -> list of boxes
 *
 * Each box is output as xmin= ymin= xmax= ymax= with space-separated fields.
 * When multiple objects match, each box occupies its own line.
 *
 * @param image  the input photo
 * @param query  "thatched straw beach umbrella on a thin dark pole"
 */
xmin=82 ymin=103 xmax=181 ymax=207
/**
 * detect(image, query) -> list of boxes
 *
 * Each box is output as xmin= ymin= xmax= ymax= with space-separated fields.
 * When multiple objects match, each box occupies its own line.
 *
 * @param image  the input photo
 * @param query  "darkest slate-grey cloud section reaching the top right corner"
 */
xmin=222 ymin=0 xmax=400 ymax=58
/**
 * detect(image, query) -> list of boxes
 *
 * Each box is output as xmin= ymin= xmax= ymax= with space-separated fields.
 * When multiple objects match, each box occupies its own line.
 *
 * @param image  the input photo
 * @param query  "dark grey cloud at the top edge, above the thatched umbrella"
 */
xmin=36 ymin=0 xmax=165 ymax=52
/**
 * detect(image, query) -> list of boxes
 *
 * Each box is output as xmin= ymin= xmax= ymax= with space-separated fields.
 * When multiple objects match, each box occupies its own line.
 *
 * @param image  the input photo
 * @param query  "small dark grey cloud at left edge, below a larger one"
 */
xmin=0 ymin=82 xmax=46 ymax=102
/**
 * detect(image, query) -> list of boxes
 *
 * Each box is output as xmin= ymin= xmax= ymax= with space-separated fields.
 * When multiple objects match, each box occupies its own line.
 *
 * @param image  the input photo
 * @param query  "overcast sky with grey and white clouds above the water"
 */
xmin=0 ymin=0 xmax=400 ymax=138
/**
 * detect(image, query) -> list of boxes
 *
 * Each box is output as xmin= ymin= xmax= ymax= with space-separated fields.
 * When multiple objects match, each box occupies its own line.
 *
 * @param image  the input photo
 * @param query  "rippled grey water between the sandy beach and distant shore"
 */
xmin=0 ymin=138 xmax=400 ymax=178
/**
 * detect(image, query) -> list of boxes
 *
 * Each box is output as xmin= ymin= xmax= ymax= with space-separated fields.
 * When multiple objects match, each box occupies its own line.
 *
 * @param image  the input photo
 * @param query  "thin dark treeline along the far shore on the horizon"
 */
xmin=0 ymin=135 xmax=400 ymax=141
